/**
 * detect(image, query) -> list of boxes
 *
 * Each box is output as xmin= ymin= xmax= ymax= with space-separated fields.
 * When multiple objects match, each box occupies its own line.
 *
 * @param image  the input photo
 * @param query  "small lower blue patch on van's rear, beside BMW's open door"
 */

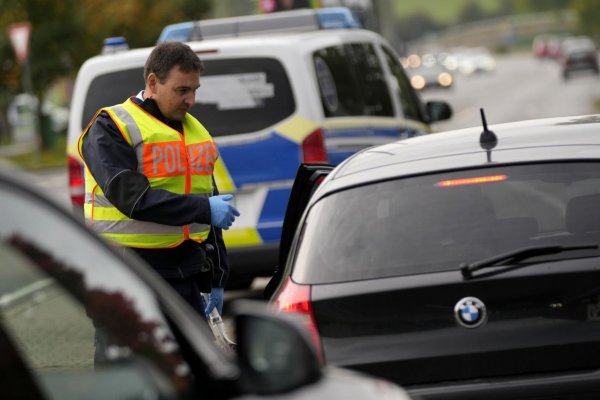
xmin=257 ymin=187 xmax=292 ymax=242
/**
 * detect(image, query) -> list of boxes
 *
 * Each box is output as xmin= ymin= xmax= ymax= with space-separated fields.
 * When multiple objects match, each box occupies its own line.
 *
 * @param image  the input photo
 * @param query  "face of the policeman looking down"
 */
xmin=146 ymin=66 xmax=200 ymax=121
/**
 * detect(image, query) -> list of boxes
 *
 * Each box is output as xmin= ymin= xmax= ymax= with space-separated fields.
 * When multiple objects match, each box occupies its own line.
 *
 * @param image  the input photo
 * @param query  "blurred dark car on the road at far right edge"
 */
xmin=559 ymin=36 xmax=600 ymax=80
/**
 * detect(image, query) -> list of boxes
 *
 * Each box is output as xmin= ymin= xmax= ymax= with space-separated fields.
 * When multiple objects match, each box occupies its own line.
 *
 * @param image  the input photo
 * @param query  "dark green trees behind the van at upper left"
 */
xmin=0 ymin=0 xmax=210 ymax=144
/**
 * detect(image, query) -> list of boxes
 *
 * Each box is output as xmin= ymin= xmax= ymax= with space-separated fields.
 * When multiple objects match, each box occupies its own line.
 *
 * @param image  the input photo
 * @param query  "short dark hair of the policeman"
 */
xmin=144 ymin=42 xmax=204 ymax=83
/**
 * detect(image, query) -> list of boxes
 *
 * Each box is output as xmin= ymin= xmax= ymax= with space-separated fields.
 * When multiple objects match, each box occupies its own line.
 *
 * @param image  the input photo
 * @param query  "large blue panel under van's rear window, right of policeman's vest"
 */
xmin=219 ymin=133 xmax=300 ymax=187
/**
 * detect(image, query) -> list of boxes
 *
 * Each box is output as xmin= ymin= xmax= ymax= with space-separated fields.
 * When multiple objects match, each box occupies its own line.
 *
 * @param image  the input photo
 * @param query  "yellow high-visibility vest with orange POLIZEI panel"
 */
xmin=79 ymin=99 xmax=218 ymax=248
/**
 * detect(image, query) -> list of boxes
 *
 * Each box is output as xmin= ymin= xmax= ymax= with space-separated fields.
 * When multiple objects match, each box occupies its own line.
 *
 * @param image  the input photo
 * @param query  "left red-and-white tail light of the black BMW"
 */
xmin=273 ymin=277 xmax=324 ymax=361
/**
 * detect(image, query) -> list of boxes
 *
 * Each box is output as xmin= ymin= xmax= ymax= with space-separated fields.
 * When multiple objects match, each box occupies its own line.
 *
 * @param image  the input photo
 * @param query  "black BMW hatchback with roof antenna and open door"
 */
xmin=269 ymin=115 xmax=600 ymax=399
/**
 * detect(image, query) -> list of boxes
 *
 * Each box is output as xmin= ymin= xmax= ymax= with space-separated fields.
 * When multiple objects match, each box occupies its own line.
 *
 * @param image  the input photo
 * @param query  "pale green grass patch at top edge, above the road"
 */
xmin=393 ymin=0 xmax=501 ymax=24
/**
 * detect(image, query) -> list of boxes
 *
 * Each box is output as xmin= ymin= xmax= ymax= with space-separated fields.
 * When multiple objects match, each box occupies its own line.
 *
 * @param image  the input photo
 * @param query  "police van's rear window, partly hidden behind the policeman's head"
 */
xmin=81 ymin=58 xmax=296 ymax=136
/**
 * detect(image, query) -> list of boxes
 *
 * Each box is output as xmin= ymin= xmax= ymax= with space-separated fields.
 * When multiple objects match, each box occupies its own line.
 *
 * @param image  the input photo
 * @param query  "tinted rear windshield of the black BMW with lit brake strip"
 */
xmin=293 ymin=163 xmax=600 ymax=284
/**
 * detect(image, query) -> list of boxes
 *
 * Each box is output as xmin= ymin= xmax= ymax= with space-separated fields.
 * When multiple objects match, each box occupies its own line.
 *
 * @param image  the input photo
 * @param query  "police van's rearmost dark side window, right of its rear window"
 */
xmin=313 ymin=43 xmax=394 ymax=117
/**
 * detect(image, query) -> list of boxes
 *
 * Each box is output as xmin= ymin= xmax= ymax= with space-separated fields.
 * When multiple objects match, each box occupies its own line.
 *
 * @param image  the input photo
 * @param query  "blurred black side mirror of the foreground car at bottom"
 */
xmin=233 ymin=300 xmax=322 ymax=395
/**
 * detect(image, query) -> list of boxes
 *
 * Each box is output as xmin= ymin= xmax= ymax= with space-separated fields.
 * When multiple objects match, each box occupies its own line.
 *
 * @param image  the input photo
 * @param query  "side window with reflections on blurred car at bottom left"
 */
xmin=0 ymin=183 xmax=191 ymax=399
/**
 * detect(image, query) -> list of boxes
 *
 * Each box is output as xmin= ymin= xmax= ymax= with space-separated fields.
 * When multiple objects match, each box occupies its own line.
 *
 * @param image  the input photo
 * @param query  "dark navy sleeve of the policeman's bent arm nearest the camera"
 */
xmin=82 ymin=112 xmax=211 ymax=226
